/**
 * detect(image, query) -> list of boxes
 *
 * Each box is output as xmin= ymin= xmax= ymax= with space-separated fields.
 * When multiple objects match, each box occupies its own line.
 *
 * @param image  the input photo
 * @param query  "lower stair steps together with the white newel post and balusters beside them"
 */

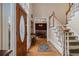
xmin=65 ymin=27 xmax=79 ymax=56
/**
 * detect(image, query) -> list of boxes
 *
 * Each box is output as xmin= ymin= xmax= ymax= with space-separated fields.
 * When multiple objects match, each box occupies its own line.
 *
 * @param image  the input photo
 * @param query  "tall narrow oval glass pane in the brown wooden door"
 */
xmin=20 ymin=16 xmax=25 ymax=42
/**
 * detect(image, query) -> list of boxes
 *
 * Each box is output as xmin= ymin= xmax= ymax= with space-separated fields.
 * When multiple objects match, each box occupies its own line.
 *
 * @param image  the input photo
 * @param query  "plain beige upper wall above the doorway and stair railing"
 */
xmin=32 ymin=3 xmax=68 ymax=24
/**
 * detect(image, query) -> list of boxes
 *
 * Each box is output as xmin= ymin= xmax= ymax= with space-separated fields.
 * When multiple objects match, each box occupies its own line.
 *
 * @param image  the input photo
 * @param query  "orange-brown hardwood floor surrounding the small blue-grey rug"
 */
xmin=28 ymin=38 xmax=61 ymax=56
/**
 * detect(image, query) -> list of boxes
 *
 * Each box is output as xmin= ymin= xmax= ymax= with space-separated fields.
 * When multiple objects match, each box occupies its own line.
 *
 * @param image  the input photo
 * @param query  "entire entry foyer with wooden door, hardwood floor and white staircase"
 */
xmin=0 ymin=3 xmax=79 ymax=56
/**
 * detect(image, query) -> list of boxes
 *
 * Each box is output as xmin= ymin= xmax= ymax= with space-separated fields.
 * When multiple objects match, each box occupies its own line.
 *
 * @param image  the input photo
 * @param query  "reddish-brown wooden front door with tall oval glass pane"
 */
xmin=16 ymin=4 xmax=27 ymax=56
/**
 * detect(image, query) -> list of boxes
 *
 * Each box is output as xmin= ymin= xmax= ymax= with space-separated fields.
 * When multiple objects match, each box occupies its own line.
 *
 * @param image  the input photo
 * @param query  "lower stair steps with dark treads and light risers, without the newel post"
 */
xmin=69 ymin=32 xmax=79 ymax=56
